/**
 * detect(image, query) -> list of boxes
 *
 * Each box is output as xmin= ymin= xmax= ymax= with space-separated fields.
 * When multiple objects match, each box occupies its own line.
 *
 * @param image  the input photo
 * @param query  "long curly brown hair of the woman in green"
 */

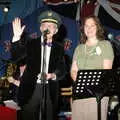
xmin=80 ymin=15 xmax=105 ymax=43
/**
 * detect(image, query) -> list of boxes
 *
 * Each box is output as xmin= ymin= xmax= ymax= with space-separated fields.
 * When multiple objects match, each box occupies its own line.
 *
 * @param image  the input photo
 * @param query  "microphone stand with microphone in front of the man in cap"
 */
xmin=39 ymin=34 xmax=47 ymax=120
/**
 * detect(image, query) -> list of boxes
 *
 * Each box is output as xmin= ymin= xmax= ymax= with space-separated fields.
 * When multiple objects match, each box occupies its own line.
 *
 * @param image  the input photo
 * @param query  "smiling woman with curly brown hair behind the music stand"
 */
xmin=71 ymin=16 xmax=114 ymax=120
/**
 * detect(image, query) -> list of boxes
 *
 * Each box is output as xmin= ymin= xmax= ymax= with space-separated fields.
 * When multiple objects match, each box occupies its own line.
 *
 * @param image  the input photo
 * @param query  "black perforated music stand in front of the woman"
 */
xmin=72 ymin=69 xmax=120 ymax=120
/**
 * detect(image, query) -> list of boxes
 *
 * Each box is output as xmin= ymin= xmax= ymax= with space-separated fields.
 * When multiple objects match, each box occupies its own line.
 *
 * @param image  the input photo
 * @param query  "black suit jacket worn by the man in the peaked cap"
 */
xmin=11 ymin=38 xmax=65 ymax=106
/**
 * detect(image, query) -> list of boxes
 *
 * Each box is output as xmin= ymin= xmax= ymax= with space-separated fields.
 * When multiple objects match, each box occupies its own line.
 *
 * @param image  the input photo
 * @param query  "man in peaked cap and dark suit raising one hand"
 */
xmin=11 ymin=11 xmax=65 ymax=120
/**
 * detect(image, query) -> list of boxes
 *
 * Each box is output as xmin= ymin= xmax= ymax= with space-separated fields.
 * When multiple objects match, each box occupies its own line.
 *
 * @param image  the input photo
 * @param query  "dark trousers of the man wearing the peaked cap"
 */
xmin=19 ymin=83 xmax=57 ymax=120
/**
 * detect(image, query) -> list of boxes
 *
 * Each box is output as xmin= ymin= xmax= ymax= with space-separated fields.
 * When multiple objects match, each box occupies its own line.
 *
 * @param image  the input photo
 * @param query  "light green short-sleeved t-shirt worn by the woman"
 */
xmin=73 ymin=40 xmax=114 ymax=70
